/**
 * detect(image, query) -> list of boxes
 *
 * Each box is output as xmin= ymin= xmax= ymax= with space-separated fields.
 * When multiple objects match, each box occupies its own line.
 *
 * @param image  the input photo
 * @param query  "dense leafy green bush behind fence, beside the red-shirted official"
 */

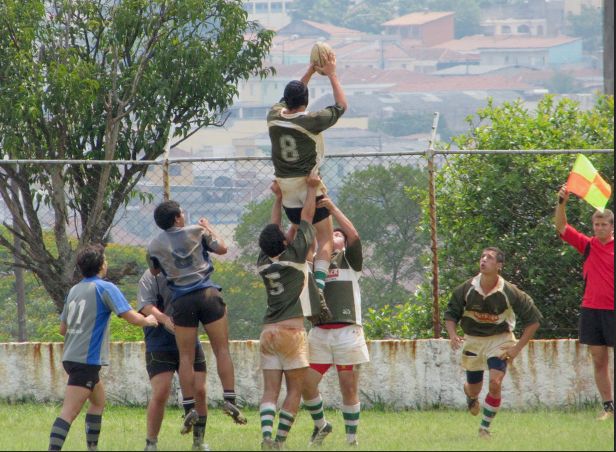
xmin=424 ymin=96 xmax=614 ymax=337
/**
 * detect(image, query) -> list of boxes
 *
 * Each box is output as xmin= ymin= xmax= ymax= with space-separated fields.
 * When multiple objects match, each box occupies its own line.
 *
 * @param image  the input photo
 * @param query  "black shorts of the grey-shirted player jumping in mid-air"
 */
xmin=173 ymin=287 xmax=226 ymax=328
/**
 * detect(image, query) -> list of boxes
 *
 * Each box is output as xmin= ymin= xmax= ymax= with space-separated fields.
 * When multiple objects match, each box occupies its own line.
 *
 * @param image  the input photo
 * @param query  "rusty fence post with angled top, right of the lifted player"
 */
xmin=426 ymin=112 xmax=441 ymax=339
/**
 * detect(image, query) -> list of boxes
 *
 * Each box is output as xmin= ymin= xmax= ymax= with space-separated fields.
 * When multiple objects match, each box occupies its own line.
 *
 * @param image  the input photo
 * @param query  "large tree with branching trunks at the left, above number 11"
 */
xmin=0 ymin=0 xmax=272 ymax=310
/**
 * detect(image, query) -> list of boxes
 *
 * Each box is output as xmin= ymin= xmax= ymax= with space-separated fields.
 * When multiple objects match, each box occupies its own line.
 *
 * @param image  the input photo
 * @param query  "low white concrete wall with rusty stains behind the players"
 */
xmin=0 ymin=339 xmax=614 ymax=408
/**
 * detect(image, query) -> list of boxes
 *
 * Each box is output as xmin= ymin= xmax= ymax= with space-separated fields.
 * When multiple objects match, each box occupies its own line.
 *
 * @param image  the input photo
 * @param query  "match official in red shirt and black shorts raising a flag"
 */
xmin=554 ymin=185 xmax=615 ymax=420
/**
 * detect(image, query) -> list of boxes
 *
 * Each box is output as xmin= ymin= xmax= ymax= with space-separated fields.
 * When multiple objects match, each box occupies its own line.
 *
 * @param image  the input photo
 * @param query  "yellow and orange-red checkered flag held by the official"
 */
xmin=567 ymin=154 xmax=612 ymax=212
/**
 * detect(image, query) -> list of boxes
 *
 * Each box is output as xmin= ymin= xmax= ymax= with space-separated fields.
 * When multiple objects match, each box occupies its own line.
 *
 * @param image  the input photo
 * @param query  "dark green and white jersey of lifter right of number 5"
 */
xmin=324 ymin=240 xmax=363 ymax=325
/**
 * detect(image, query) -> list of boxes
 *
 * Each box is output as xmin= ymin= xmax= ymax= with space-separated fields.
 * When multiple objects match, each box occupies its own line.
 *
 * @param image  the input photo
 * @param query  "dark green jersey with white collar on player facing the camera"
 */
xmin=445 ymin=275 xmax=543 ymax=336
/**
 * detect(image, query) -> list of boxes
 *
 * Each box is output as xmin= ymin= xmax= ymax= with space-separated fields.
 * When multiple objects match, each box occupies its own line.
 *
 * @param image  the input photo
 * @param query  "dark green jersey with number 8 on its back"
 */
xmin=267 ymin=102 xmax=344 ymax=178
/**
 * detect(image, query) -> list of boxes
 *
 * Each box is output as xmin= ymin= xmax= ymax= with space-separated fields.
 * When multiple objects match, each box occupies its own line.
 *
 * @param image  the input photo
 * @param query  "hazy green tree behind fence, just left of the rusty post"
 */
xmin=338 ymin=164 xmax=428 ymax=291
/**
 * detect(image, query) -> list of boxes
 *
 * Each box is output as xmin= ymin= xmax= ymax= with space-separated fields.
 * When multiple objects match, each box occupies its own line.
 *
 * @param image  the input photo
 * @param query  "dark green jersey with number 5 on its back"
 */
xmin=257 ymin=220 xmax=319 ymax=323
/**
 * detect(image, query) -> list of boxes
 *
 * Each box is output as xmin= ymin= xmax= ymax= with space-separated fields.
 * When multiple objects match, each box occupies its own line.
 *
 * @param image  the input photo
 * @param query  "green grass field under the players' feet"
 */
xmin=0 ymin=403 xmax=614 ymax=450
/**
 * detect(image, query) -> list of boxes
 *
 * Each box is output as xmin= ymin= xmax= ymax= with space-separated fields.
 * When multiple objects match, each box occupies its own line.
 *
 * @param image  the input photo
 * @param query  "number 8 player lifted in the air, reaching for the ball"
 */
xmin=267 ymin=48 xmax=347 ymax=304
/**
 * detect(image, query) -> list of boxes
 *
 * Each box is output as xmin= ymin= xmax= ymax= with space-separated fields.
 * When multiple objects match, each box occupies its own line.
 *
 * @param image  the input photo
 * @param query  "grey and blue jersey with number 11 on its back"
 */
xmin=60 ymin=276 xmax=132 ymax=366
